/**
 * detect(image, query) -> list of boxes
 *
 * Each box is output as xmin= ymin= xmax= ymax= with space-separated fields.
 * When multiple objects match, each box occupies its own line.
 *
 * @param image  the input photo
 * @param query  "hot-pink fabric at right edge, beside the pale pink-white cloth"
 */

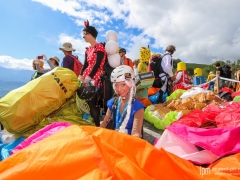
xmin=167 ymin=124 xmax=240 ymax=156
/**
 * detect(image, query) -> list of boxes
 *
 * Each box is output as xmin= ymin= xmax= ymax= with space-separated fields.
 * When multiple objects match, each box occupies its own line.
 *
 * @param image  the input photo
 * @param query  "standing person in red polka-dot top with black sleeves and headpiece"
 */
xmin=78 ymin=21 xmax=107 ymax=126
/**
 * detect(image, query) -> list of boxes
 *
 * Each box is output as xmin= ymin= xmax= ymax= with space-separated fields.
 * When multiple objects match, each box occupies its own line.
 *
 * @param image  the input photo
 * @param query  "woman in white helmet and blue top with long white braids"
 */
xmin=101 ymin=65 xmax=144 ymax=138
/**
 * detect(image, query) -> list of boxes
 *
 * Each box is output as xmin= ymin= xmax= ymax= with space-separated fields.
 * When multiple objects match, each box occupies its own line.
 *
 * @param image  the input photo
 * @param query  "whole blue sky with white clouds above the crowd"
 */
xmin=0 ymin=0 xmax=240 ymax=69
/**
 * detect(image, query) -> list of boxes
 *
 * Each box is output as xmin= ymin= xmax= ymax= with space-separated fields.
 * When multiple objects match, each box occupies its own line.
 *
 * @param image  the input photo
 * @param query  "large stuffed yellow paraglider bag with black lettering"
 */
xmin=0 ymin=67 xmax=79 ymax=135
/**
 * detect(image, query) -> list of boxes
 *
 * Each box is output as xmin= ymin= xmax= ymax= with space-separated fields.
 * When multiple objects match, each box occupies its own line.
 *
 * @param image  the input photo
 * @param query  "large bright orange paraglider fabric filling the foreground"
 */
xmin=0 ymin=125 xmax=232 ymax=180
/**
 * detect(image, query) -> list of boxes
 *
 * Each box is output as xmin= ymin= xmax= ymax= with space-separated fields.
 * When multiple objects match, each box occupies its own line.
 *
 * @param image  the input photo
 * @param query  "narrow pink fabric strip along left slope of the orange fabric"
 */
xmin=11 ymin=122 xmax=71 ymax=154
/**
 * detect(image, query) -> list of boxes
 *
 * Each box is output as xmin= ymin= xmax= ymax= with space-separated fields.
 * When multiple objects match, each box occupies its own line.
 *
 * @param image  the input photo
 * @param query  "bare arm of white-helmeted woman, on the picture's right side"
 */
xmin=131 ymin=108 xmax=144 ymax=138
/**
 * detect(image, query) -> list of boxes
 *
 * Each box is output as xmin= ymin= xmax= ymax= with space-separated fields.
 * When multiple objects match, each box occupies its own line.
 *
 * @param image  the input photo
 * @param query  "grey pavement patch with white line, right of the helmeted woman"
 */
xmin=143 ymin=120 xmax=163 ymax=144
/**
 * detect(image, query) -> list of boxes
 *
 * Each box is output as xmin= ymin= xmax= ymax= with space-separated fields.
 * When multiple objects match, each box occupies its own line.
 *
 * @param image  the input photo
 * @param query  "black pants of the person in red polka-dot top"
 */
xmin=87 ymin=94 xmax=100 ymax=126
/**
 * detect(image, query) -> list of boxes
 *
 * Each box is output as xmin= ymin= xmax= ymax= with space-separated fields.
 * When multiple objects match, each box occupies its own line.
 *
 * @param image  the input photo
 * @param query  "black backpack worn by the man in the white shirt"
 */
xmin=150 ymin=53 xmax=168 ymax=78
